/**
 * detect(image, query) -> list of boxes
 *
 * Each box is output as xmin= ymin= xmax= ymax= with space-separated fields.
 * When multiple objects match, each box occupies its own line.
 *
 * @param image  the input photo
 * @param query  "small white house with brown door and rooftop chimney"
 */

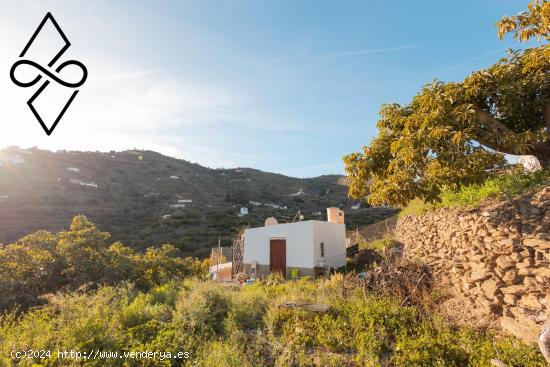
xmin=243 ymin=208 xmax=346 ymax=276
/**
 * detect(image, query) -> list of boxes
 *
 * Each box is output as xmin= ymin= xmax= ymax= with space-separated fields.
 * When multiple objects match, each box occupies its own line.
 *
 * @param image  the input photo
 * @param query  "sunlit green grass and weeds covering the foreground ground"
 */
xmin=0 ymin=275 xmax=545 ymax=367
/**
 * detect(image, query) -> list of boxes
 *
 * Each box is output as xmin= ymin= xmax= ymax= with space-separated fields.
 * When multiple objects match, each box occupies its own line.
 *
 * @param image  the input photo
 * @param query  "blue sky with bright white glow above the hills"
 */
xmin=0 ymin=0 xmax=527 ymax=177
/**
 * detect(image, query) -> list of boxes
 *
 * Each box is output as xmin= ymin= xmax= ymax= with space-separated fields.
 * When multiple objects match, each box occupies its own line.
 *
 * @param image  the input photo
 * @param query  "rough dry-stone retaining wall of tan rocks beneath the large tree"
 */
xmin=396 ymin=187 xmax=550 ymax=342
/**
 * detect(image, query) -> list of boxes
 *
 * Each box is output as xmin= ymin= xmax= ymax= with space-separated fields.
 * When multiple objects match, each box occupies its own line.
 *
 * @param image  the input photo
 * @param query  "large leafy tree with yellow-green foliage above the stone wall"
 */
xmin=344 ymin=0 xmax=550 ymax=205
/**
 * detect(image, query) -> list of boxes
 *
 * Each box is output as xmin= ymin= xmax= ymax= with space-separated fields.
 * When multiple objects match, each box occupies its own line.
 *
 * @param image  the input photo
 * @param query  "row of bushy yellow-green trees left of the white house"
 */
xmin=0 ymin=215 xmax=207 ymax=310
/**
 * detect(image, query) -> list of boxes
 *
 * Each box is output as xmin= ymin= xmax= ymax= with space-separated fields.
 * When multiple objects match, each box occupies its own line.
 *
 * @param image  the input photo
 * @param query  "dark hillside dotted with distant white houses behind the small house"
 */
xmin=0 ymin=148 xmax=385 ymax=256
